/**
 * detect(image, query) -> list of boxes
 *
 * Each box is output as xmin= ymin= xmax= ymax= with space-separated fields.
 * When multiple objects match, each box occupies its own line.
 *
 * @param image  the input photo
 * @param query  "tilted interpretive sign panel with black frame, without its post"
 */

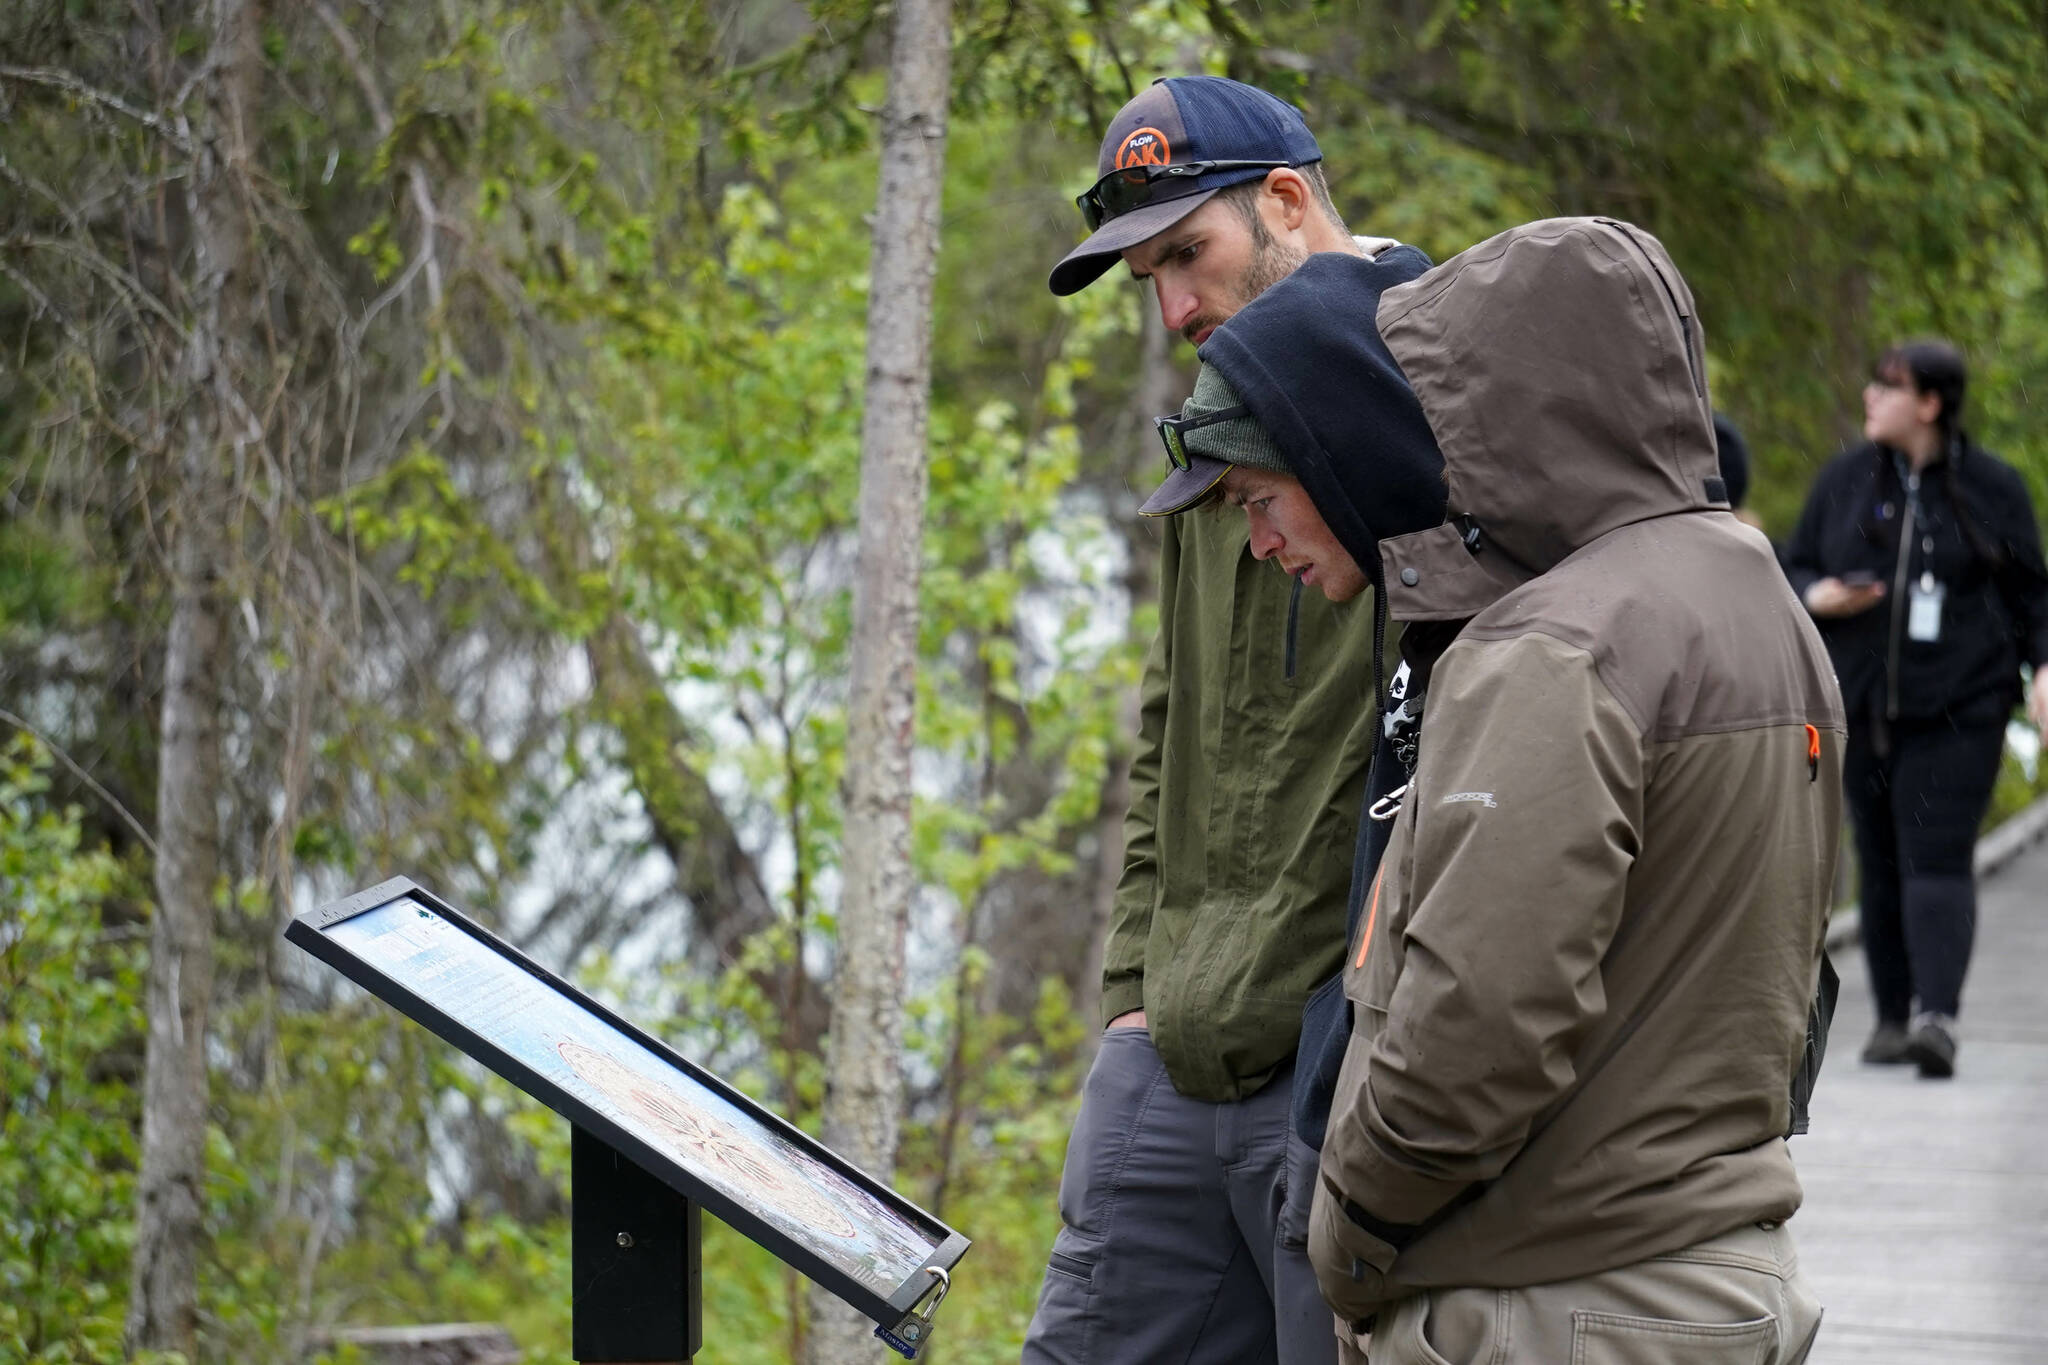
xmin=285 ymin=878 xmax=969 ymax=1328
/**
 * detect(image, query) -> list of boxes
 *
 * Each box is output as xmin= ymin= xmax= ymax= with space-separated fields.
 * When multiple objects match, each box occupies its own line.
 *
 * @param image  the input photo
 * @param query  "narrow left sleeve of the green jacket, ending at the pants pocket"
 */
xmin=1102 ymin=518 xmax=1180 ymax=1025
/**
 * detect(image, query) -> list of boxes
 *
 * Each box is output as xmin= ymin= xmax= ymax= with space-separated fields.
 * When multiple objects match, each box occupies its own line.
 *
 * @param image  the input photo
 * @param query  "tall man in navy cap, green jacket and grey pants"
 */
xmin=1024 ymin=76 xmax=1430 ymax=1365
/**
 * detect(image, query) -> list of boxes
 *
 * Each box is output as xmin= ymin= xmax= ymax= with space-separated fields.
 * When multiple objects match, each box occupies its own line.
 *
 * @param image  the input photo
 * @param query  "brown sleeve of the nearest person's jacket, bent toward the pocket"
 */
xmin=1325 ymin=634 xmax=1645 ymax=1242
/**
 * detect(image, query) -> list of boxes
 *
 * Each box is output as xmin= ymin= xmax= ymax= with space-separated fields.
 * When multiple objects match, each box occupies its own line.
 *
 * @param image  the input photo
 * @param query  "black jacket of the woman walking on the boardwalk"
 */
xmin=1784 ymin=442 xmax=2048 ymax=726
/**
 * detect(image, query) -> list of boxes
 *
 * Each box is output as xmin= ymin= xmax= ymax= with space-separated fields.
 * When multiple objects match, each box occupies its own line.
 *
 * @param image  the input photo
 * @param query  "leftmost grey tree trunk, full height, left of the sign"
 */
xmin=127 ymin=0 xmax=260 ymax=1359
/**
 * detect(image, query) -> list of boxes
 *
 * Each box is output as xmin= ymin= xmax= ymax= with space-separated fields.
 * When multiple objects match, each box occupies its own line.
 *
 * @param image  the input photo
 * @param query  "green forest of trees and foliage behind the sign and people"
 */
xmin=0 ymin=0 xmax=2048 ymax=1365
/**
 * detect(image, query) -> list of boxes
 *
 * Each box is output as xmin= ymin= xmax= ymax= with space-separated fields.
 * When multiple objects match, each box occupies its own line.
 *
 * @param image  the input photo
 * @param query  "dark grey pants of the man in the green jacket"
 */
xmin=1024 ymin=1027 xmax=1337 ymax=1365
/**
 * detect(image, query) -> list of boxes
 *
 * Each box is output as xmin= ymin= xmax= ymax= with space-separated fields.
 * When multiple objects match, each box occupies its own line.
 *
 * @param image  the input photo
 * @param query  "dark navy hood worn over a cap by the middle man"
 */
xmin=1200 ymin=246 xmax=1444 ymax=583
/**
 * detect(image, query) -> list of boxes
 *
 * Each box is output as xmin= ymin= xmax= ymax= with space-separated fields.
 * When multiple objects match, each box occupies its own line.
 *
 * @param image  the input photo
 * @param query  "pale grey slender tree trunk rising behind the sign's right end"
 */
xmin=805 ymin=0 xmax=952 ymax=1365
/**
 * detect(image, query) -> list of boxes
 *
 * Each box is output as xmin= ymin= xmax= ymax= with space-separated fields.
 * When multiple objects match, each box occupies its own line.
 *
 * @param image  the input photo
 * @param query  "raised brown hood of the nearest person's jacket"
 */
xmin=1376 ymin=219 xmax=1729 ymax=620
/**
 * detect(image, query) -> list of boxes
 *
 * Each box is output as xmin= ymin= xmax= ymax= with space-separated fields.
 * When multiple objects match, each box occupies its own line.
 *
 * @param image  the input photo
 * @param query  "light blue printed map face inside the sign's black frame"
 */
xmin=324 ymin=896 xmax=952 ymax=1300
